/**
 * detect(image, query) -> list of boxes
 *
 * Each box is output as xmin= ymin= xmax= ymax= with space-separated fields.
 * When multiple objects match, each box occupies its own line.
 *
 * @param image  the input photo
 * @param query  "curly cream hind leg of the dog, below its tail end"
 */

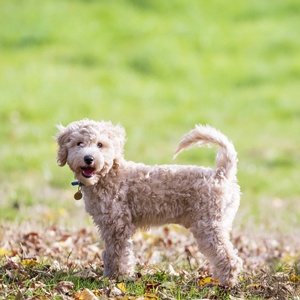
xmin=191 ymin=222 xmax=242 ymax=285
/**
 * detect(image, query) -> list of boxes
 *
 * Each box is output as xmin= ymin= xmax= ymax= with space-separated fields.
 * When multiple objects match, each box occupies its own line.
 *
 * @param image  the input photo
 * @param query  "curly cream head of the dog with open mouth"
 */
xmin=56 ymin=119 xmax=125 ymax=185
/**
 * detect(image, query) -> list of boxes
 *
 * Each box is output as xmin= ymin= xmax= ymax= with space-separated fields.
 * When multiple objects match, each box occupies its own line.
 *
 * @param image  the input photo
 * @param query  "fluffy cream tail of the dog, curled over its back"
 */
xmin=174 ymin=125 xmax=238 ymax=180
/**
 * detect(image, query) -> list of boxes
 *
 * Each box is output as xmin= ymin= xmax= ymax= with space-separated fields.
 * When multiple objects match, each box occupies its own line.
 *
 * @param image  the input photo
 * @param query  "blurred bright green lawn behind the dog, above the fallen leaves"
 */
xmin=0 ymin=0 xmax=300 ymax=232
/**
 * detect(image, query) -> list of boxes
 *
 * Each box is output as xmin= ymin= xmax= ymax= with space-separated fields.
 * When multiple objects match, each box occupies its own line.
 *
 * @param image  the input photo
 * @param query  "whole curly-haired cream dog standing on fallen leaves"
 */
xmin=56 ymin=119 xmax=242 ymax=285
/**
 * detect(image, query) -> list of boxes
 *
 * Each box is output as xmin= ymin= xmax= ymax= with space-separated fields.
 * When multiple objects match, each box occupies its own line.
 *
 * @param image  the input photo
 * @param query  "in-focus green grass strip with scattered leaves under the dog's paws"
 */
xmin=0 ymin=256 xmax=300 ymax=300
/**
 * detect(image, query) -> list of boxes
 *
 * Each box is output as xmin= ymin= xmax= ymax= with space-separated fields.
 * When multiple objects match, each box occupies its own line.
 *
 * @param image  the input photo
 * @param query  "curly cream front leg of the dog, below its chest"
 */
xmin=101 ymin=222 xmax=135 ymax=278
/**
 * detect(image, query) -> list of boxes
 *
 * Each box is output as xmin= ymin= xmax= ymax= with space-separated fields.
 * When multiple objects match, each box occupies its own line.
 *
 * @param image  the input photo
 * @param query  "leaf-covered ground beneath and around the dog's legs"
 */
xmin=0 ymin=224 xmax=300 ymax=299
